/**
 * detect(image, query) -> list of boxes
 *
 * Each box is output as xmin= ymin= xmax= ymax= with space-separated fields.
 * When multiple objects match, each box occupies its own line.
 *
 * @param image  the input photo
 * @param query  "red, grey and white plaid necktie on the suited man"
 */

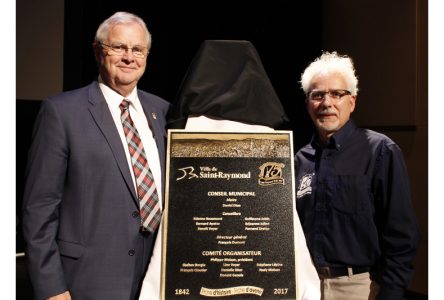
xmin=119 ymin=99 xmax=162 ymax=232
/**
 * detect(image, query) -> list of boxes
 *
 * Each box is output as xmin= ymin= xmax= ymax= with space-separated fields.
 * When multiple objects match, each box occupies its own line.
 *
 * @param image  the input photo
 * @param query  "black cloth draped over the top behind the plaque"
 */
xmin=168 ymin=40 xmax=288 ymax=129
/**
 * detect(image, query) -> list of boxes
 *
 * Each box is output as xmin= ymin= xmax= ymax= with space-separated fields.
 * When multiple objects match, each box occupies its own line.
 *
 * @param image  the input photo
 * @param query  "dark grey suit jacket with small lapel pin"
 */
xmin=23 ymin=82 xmax=169 ymax=300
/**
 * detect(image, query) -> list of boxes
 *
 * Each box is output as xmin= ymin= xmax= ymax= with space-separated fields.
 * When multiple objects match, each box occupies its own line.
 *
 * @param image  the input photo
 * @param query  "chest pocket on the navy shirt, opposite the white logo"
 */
xmin=326 ymin=175 xmax=372 ymax=215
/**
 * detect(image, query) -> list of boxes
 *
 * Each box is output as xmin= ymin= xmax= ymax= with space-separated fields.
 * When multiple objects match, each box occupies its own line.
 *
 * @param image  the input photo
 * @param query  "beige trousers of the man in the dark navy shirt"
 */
xmin=321 ymin=272 xmax=379 ymax=300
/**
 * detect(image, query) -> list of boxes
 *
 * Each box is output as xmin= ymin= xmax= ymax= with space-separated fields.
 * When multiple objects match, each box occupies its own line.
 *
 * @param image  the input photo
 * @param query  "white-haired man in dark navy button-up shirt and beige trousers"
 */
xmin=295 ymin=52 xmax=419 ymax=300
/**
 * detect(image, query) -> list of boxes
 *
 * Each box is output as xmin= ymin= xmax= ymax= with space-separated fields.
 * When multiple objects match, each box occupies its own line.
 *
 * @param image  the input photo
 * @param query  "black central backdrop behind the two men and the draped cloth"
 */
xmin=64 ymin=0 xmax=322 ymax=149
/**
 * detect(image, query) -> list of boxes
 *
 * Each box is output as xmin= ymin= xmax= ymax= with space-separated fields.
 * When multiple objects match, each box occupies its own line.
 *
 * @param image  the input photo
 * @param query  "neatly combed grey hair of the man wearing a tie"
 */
xmin=94 ymin=11 xmax=151 ymax=50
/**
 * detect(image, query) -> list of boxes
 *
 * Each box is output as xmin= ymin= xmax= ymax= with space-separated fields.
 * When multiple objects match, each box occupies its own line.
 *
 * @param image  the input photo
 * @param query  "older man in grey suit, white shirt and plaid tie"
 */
xmin=23 ymin=12 xmax=169 ymax=300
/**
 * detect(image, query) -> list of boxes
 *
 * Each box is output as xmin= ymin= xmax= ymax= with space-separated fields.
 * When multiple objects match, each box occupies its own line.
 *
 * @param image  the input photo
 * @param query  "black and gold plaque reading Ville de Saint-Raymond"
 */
xmin=162 ymin=130 xmax=297 ymax=299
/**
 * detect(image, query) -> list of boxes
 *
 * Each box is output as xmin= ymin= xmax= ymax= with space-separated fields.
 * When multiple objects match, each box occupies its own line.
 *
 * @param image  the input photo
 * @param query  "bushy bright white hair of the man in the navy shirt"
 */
xmin=300 ymin=51 xmax=358 ymax=96
